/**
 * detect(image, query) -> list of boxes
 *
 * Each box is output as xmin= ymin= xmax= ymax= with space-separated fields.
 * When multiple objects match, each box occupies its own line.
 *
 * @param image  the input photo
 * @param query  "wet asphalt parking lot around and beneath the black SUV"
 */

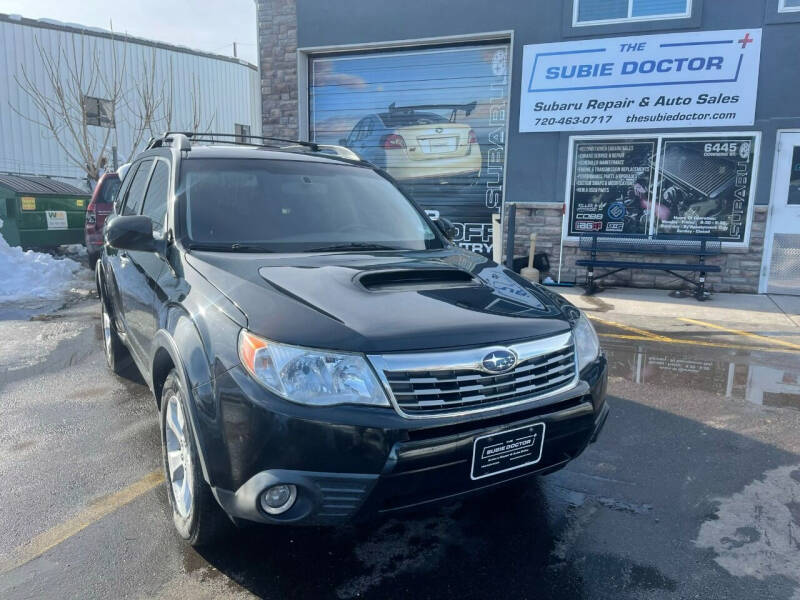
xmin=0 ymin=284 xmax=800 ymax=600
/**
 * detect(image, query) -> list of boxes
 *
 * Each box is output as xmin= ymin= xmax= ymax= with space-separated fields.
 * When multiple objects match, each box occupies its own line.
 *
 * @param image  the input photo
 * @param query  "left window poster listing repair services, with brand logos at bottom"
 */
xmin=569 ymin=138 xmax=658 ymax=235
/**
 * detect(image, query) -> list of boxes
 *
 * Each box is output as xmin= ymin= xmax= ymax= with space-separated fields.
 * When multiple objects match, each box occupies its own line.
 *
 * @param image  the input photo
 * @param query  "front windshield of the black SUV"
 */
xmin=180 ymin=159 xmax=442 ymax=252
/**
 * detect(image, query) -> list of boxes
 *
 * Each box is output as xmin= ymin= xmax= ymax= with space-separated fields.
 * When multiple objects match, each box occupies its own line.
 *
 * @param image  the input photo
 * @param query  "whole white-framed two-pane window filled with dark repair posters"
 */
xmin=567 ymin=134 xmax=758 ymax=243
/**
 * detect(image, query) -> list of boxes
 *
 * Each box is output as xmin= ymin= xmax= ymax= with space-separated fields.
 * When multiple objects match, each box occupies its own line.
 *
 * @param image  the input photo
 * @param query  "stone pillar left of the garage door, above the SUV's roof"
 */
xmin=256 ymin=0 xmax=298 ymax=139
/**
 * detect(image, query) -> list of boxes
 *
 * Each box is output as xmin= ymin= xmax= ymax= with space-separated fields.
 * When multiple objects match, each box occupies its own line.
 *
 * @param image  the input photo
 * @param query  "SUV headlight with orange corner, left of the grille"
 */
xmin=239 ymin=329 xmax=389 ymax=406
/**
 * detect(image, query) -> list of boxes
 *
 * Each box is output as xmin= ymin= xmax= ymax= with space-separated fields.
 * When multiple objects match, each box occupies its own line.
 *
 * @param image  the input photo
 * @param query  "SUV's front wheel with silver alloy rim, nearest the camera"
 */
xmin=161 ymin=369 xmax=229 ymax=547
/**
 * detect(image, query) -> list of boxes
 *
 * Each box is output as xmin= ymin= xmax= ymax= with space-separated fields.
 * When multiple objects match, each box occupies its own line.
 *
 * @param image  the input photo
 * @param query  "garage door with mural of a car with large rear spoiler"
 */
xmin=309 ymin=43 xmax=509 ymax=255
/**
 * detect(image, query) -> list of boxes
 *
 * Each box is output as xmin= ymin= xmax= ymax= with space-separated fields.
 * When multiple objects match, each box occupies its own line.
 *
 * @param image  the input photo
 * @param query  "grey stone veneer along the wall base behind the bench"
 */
xmin=504 ymin=202 xmax=767 ymax=294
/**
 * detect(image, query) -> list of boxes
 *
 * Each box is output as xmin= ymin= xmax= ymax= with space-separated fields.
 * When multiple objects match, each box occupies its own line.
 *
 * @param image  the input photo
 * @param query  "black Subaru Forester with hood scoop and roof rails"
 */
xmin=97 ymin=134 xmax=608 ymax=545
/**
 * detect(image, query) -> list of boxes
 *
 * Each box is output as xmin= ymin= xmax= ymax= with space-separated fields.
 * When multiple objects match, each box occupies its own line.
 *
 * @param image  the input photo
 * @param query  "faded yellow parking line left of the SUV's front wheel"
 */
xmin=0 ymin=470 xmax=164 ymax=573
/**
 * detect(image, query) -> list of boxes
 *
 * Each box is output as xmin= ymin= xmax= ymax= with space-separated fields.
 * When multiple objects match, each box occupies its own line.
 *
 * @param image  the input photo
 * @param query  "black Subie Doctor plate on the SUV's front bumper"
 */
xmin=470 ymin=423 xmax=544 ymax=479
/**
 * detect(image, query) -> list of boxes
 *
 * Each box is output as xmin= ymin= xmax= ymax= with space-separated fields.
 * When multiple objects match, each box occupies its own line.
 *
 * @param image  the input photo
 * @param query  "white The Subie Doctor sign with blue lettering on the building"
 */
xmin=519 ymin=29 xmax=761 ymax=132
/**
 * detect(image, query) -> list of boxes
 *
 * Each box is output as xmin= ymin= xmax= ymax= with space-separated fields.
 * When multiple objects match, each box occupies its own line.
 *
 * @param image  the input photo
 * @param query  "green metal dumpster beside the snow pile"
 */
xmin=0 ymin=175 xmax=91 ymax=248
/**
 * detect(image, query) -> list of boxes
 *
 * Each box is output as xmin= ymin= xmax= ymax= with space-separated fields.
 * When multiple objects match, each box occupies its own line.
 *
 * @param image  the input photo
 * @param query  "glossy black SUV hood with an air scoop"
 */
xmin=187 ymin=248 xmax=570 ymax=352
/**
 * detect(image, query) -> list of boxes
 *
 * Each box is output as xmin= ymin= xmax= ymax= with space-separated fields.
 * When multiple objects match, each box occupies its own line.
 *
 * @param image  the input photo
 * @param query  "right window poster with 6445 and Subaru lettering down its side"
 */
xmin=654 ymin=136 xmax=755 ymax=242
